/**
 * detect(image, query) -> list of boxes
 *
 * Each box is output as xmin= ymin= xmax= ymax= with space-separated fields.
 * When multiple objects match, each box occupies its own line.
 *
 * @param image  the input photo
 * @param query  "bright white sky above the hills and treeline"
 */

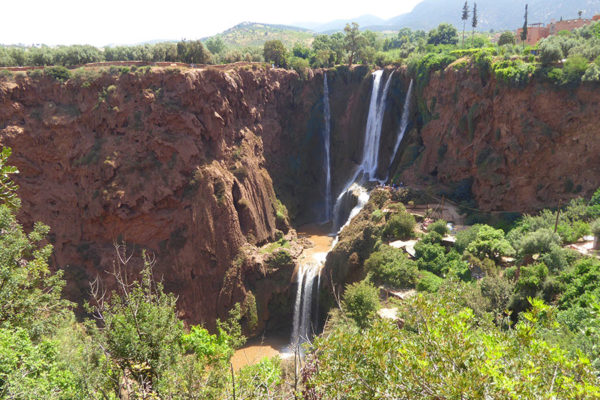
xmin=0 ymin=0 xmax=422 ymax=46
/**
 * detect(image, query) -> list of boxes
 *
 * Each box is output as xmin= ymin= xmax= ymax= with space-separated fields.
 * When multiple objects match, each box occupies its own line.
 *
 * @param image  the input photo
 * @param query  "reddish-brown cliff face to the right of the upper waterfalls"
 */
xmin=400 ymin=68 xmax=600 ymax=212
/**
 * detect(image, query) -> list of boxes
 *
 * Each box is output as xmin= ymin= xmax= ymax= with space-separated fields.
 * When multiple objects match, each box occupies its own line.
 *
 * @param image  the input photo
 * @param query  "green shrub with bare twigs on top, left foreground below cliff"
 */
xmin=89 ymin=250 xmax=184 ymax=398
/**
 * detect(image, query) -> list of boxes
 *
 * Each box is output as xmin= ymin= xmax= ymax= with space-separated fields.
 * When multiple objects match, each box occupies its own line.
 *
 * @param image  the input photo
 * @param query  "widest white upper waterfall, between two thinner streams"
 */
xmin=333 ymin=70 xmax=394 ymax=233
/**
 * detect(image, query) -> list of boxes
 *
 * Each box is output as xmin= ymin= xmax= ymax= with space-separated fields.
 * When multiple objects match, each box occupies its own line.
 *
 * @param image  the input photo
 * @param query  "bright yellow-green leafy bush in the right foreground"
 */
xmin=305 ymin=294 xmax=600 ymax=399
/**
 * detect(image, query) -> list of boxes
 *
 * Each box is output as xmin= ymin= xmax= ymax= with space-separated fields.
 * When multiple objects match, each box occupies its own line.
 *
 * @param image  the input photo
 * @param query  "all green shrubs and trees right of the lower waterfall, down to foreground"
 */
xmin=304 ymin=182 xmax=600 ymax=399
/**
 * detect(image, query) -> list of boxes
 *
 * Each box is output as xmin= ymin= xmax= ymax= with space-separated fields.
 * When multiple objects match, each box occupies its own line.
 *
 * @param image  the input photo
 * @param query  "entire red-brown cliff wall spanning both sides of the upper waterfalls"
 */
xmin=0 ymin=64 xmax=600 ymax=336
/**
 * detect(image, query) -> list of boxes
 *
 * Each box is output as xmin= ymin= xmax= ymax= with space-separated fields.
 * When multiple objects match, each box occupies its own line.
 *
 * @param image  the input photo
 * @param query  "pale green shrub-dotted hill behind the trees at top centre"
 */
xmin=203 ymin=22 xmax=315 ymax=48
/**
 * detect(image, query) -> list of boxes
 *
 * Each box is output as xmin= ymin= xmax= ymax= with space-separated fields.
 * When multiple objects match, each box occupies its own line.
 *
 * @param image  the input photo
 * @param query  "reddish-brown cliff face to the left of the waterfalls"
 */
xmin=0 ymin=67 xmax=332 ymax=326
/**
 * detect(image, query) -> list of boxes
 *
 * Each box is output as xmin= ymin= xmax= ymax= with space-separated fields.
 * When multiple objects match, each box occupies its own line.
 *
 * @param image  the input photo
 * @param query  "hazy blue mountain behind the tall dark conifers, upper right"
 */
xmin=299 ymin=0 xmax=600 ymax=33
